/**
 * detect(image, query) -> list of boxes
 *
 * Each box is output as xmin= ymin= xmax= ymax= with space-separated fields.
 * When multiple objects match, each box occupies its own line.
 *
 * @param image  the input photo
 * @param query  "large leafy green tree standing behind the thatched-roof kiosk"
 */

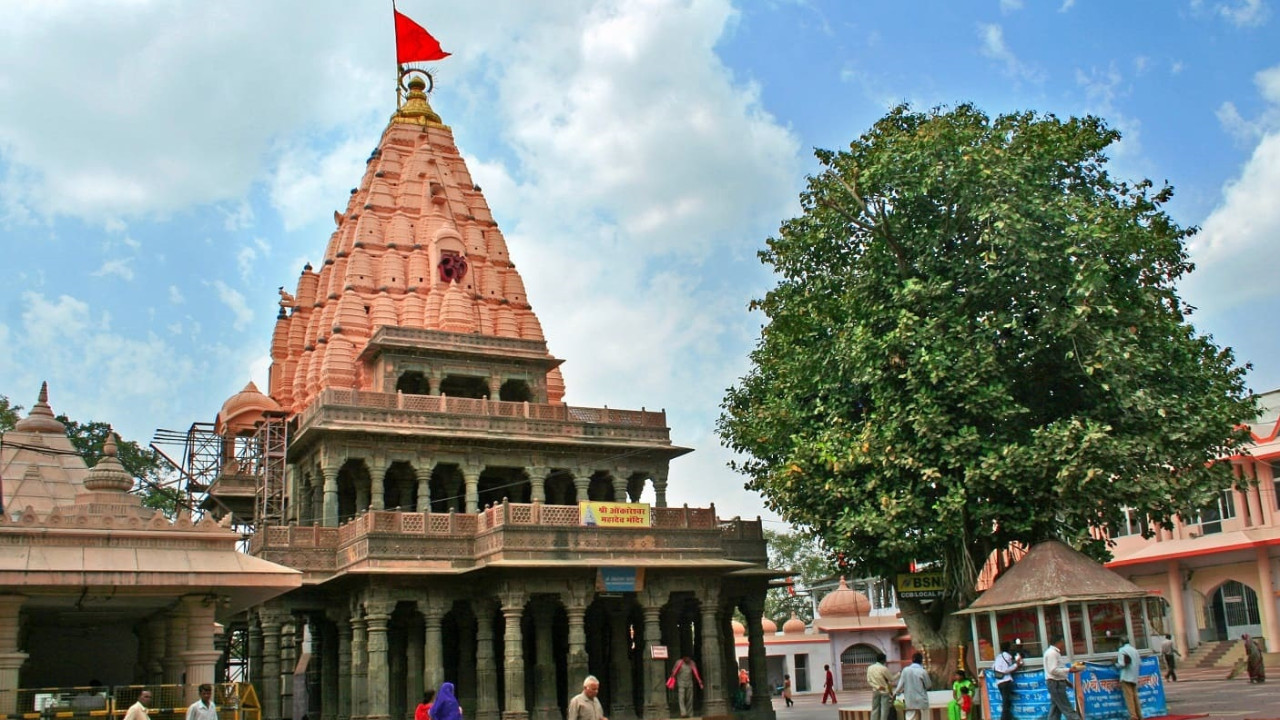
xmin=719 ymin=105 xmax=1254 ymax=669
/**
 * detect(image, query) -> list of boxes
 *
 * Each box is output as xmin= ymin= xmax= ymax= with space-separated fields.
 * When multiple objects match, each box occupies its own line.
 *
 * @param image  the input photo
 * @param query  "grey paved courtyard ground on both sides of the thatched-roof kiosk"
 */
xmin=773 ymin=670 xmax=1280 ymax=720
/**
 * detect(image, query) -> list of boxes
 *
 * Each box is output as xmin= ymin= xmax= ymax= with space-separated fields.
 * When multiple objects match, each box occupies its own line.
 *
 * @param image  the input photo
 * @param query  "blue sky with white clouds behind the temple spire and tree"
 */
xmin=0 ymin=0 xmax=1280 ymax=516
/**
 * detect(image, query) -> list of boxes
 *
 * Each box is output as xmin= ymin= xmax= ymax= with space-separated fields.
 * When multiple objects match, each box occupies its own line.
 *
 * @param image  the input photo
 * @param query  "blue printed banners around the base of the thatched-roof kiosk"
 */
xmin=983 ymin=655 xmax=1169 ymax=720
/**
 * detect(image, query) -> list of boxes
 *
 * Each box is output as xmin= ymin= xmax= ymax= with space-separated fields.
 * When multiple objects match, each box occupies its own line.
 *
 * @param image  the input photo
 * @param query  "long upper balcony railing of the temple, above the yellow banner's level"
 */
xmin=291 ymin=388 xmax=671 ymax=446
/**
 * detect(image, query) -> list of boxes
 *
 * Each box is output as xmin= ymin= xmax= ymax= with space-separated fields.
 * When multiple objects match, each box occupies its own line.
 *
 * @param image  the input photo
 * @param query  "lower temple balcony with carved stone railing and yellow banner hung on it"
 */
xmin=250 ymin=502 xmax=767 ymax=583
